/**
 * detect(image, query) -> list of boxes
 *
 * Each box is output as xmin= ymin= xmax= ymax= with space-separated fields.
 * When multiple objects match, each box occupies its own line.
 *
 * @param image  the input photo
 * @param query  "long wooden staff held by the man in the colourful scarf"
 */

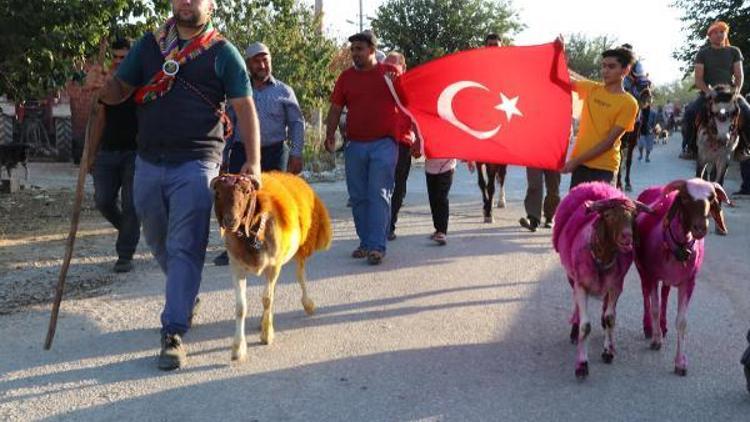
xmin=44 ymin=38 xmax=107 ymax=350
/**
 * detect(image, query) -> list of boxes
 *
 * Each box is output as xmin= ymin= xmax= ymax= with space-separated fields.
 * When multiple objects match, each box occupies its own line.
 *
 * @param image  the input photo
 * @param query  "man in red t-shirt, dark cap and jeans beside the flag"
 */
xmin=326 ymin=33 xmax=399 ymax=265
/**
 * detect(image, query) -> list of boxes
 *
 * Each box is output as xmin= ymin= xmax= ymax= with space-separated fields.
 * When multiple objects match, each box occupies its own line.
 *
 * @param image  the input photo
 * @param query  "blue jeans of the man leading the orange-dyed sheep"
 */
xmin=134 ymin=157 xmax=219 ymax=334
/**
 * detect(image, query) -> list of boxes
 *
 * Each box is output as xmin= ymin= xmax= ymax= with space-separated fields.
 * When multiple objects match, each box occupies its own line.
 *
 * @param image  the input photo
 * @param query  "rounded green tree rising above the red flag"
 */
xmin=372 ymin=0 xmax=524 ymax=66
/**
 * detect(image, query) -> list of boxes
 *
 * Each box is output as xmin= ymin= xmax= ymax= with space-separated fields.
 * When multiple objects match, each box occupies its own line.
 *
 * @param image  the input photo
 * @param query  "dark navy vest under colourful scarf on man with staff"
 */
xmin=138 ymin=33 xmax=226 ymax=163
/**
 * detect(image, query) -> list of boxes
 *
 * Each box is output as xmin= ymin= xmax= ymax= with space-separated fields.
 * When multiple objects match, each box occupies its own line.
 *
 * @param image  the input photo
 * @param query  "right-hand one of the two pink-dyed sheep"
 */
xmin=635 ymin=178 xmax=729 ymax=376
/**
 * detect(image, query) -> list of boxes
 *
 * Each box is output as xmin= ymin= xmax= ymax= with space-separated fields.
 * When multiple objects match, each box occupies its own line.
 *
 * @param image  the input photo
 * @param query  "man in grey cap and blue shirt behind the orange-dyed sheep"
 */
xmin=214 ymin=42 xmax=305 ymax=266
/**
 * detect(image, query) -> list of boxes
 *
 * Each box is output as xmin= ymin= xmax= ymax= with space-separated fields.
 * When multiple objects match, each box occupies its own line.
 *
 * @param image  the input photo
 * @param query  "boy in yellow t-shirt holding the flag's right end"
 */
xmin=561 ymin=48 xmax=638 ymax=189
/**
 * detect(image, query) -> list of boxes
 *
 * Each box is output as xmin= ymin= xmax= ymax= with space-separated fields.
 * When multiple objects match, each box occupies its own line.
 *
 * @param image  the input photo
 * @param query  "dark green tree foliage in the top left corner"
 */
xmin=0 ymin=0 xmax=165 ymax=101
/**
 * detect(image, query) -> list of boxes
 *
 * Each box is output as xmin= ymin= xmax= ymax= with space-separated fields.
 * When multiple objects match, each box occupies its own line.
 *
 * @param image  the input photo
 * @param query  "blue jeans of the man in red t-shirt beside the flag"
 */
xmin=344 ymin=138 xmax=398 ymax=253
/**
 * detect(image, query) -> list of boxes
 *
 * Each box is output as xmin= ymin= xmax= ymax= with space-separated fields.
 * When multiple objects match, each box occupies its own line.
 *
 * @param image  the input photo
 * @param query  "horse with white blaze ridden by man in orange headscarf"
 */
xmin=695 ymin=85 xmax=743 ymax=185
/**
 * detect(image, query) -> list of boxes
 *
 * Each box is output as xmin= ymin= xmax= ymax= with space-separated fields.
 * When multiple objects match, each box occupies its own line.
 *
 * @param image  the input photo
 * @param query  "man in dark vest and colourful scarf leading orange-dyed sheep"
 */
xmin=92 ymin=0 xmax=260 ymax=370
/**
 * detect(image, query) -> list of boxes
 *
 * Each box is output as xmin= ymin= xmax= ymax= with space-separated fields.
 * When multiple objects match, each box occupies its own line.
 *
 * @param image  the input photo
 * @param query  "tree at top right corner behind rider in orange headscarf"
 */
xmin=673 ymin=0 xmax=750 ymax=92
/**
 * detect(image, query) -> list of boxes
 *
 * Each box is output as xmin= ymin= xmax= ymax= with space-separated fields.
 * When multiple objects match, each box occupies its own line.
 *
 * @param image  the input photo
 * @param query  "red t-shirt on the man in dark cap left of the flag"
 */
xmin=331 ymin=64 xmax=399 ymax=141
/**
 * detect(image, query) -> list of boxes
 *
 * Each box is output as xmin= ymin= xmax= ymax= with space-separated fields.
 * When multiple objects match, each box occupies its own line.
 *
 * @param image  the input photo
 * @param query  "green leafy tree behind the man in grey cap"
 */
xmin=214 ymin=0 xmax=338 ymax=114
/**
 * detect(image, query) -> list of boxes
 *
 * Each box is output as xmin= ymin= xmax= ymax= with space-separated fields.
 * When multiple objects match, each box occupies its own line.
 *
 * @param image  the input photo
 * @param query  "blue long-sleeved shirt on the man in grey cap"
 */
xmin=229 ymin=76 xmax=305 ymax=157
